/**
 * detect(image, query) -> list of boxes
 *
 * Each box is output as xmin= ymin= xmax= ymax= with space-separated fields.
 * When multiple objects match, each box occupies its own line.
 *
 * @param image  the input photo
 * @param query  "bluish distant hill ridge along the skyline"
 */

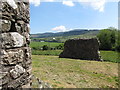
xmin=31 ymin=29 xmax=99 ymax=38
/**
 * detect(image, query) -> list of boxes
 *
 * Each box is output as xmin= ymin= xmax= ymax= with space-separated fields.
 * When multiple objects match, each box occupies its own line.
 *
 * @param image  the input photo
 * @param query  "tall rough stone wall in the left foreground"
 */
xmin=0 ymin=0 xmax=31 ymax=88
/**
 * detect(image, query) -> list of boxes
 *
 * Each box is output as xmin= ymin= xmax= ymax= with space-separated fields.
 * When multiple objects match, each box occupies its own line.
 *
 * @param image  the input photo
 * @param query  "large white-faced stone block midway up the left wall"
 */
xmin=0 ymin=32 xmax=26 ymax=48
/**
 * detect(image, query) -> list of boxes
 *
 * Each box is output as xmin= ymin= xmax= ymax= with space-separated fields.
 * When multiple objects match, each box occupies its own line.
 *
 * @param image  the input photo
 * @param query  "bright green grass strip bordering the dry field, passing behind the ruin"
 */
xmin=32 ymin=50 xmax=120 ymax=63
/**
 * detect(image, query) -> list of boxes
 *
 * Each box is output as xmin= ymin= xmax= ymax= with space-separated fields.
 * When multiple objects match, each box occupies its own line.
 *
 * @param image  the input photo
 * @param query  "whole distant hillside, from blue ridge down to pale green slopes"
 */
xmin=31 ymin=29 xmax=99 ymax=42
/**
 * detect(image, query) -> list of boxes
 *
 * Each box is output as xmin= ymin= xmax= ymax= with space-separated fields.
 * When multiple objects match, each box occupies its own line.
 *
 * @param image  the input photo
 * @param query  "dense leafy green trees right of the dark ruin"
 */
xmin=97 ymin=27 xmax=120 ymax=51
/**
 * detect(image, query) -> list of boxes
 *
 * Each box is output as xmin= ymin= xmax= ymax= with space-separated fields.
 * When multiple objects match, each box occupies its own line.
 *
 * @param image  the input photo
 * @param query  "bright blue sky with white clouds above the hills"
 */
xmin=30 ymin=0 xmax=118 ymax=33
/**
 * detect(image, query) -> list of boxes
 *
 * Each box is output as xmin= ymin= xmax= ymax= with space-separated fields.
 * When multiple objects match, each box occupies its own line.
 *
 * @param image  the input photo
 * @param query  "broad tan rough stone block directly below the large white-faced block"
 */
xmin=0 ymin=48 xmax=24 ymax=65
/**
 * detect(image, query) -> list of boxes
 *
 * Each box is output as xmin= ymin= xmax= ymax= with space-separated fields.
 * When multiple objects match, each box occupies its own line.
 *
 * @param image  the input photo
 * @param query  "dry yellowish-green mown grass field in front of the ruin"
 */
xmin=32 ymin=55 xmax=118 ymax=88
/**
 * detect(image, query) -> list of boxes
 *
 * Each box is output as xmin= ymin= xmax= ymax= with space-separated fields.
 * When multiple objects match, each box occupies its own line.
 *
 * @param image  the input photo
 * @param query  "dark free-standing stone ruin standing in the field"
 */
xmin=59 ymin=38 xmax=101 ymax=61
